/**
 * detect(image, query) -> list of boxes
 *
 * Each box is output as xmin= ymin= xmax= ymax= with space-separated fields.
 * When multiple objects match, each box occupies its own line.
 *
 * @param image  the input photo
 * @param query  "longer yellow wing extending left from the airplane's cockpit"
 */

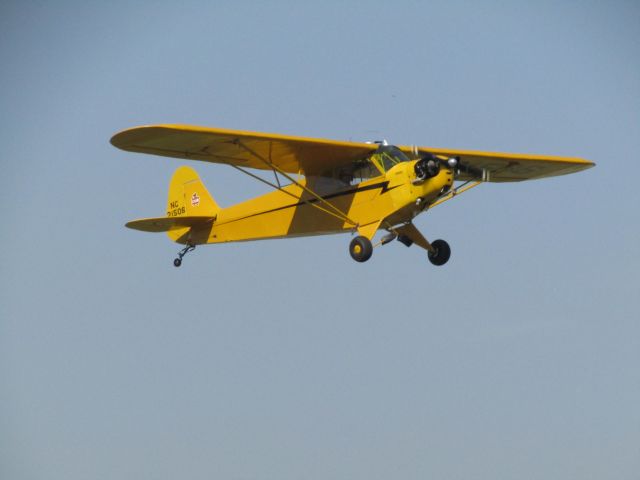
xmin=111 ymin=125 xmax=377 ymax=176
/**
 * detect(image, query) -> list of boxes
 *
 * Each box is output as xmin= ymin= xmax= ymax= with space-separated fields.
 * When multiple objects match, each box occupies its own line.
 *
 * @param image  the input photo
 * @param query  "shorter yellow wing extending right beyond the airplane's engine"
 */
xmin=408 ymin=147 xmax=595 ymax=182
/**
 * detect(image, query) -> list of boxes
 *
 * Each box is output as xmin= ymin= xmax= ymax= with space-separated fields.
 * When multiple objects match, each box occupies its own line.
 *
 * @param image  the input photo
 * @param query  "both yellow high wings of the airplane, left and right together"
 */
xmin=111 ymin=125 xmax=595 ymax=182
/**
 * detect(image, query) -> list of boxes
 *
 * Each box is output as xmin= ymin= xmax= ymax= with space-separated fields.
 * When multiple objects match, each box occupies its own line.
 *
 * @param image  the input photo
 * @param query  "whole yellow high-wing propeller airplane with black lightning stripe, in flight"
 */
xmin=111 ymin=125 xmax=594 ymax=267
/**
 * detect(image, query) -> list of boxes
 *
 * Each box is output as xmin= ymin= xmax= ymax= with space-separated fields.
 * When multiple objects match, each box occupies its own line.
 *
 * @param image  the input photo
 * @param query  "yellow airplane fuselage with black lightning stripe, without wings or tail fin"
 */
xmin=168 ymin=161 xmax=454 ymax=244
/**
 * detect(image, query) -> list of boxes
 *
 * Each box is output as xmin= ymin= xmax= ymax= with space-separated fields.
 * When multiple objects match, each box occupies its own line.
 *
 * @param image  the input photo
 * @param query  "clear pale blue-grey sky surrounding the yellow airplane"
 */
xmin=0 ymin=0 xmax=640 ymax=480
